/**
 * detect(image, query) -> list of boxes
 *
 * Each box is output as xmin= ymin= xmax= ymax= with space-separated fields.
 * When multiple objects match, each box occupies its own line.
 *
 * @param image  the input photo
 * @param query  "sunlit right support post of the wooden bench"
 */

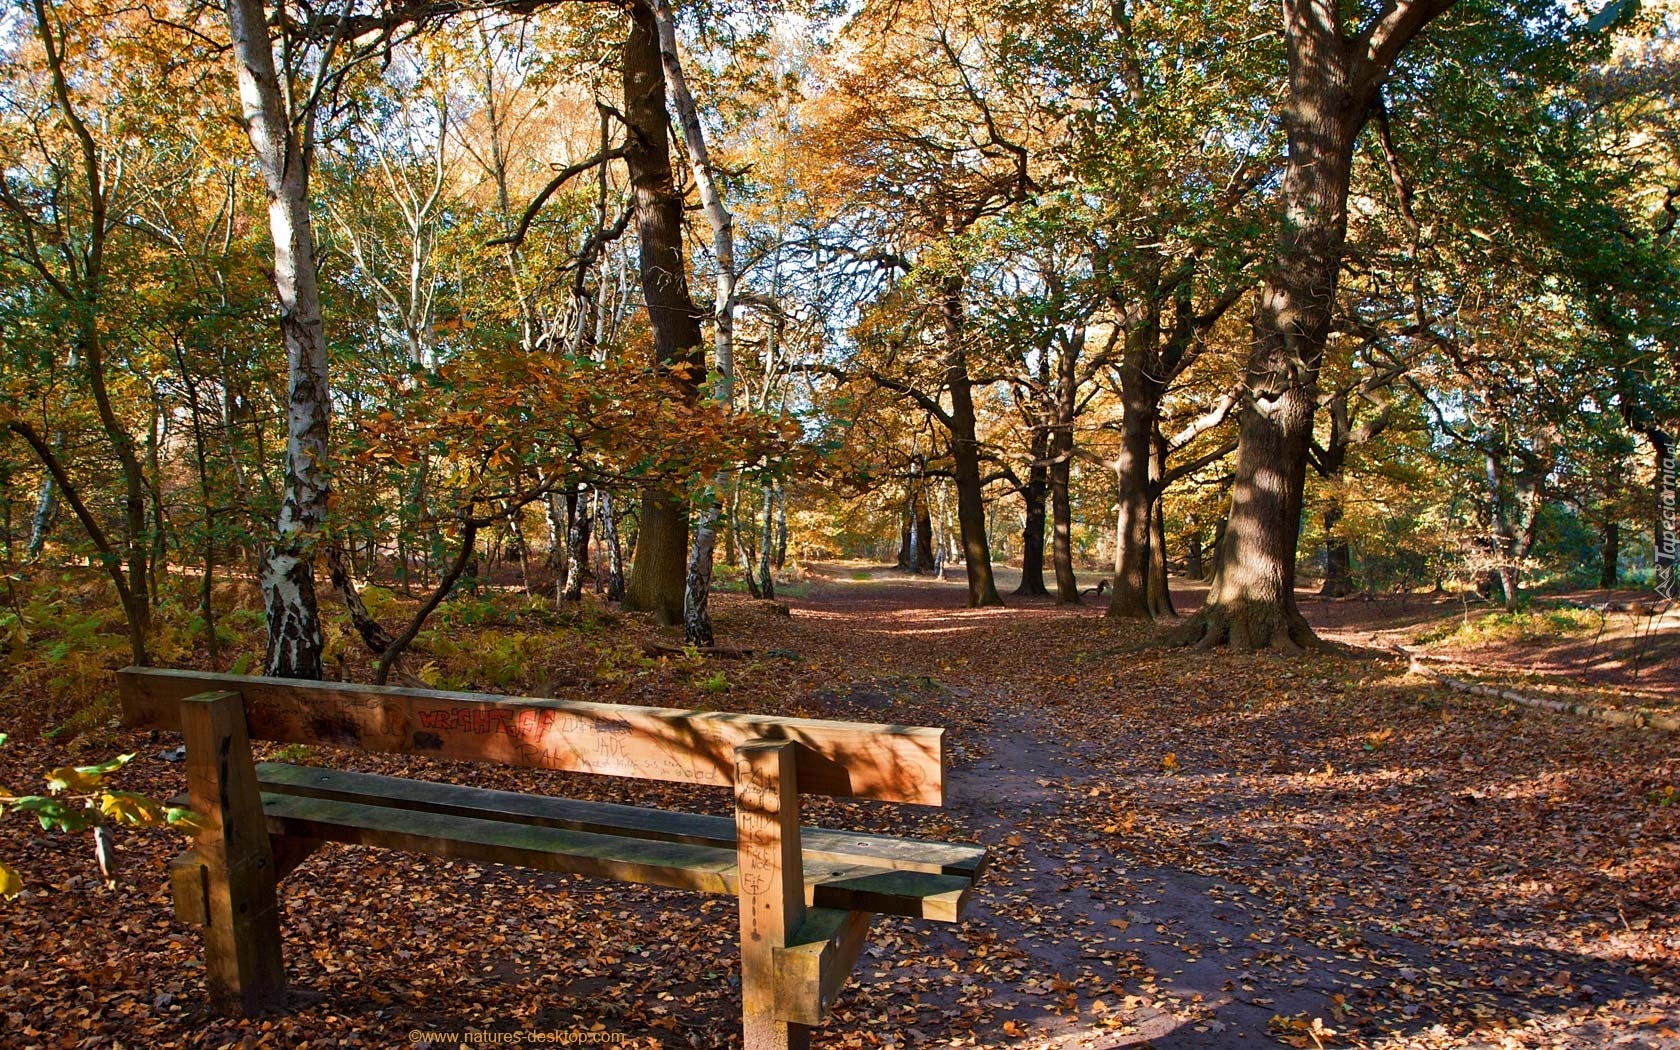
xmin=734 ymin=741 xmax=811 ymax=1050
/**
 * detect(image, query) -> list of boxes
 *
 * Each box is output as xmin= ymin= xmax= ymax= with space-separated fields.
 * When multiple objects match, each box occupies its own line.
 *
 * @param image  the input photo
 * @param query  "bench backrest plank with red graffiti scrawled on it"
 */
xmin=118 ymin=667 xmax=944 ymax=806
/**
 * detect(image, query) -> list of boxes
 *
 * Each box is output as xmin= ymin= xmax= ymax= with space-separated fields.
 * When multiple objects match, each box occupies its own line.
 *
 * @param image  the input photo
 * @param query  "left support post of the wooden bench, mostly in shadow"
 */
xmin=175 ymin=692 xmax=286 ymax=1015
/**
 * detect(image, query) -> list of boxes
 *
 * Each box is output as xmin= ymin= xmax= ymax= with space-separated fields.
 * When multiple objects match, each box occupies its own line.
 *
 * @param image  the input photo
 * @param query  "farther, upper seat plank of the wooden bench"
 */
xmin=257 ymin=763 xmax=986 ymax=882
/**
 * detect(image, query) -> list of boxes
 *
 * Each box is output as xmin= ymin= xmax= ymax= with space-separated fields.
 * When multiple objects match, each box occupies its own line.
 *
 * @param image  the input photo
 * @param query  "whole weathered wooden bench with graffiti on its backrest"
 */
xmin=118 ymin=667 xmax=986 ymax=1050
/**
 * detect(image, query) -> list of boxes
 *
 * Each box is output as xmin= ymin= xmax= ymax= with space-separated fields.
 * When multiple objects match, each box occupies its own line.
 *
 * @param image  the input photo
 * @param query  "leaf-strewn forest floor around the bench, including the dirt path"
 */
xmin=0 ymin=564 xmax=1680 ymax=1050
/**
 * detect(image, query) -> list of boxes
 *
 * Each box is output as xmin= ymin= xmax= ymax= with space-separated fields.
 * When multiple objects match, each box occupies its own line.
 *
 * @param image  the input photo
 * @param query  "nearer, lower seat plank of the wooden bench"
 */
xmin=262 ymin=791 xmax=973 ymax=922
